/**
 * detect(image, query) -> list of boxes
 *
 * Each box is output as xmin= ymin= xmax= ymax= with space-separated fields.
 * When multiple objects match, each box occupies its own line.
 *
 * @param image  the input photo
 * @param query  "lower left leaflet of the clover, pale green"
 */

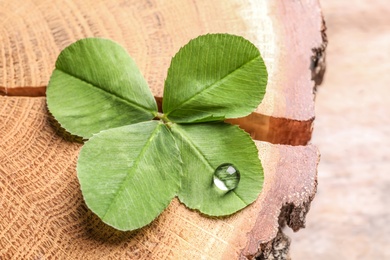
xmin=77 ymin=121 xmax=181 ymax=230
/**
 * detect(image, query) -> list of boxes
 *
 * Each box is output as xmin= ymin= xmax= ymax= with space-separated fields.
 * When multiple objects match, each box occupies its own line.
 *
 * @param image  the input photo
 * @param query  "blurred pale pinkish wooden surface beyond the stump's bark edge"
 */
xmin=286 ymin=0 xmax=390 ymax=260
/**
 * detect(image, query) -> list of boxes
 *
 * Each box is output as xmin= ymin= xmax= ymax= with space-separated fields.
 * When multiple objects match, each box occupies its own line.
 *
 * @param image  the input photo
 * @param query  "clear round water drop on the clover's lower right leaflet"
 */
xmin=214 ymin=163 xmax=240 ymax=191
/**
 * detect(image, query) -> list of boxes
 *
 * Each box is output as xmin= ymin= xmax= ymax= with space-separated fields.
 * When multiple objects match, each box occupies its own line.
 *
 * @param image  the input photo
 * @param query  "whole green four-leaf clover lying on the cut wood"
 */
xmin=47 ymin=34 xmax=267 ymax=230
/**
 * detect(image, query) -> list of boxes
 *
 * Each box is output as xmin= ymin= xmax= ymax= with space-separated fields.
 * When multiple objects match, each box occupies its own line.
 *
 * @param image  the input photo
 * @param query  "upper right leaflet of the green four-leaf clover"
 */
xmin=163 ymin=34 xmax=267 ymax=123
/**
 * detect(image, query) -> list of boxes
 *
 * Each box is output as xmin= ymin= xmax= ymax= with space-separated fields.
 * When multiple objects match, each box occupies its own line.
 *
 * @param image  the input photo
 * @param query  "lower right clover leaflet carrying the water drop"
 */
xmin=172 ymin=123 xmax=263 ymax=216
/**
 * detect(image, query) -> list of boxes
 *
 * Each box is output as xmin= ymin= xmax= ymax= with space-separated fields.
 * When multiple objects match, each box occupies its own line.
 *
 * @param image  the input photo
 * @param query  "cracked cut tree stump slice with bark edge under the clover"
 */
xmin=0 ymin=0 xmax=326 ymax=259
